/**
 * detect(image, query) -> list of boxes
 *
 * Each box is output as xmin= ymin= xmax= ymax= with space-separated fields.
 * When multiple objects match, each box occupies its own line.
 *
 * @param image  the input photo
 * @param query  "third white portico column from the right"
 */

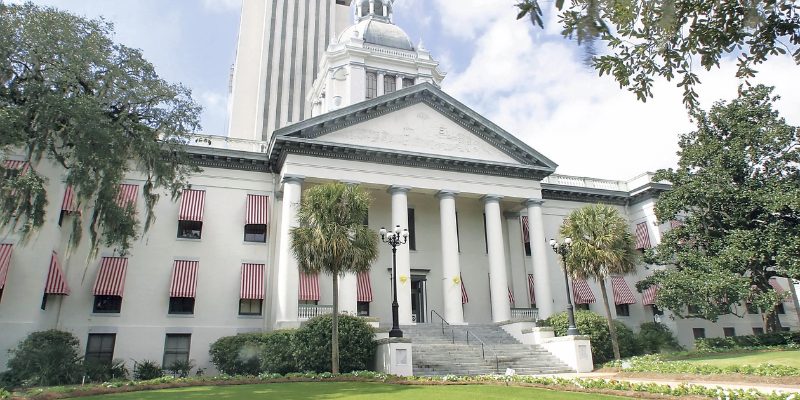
xmin=436 ymin=191 xmax=464 ymax=324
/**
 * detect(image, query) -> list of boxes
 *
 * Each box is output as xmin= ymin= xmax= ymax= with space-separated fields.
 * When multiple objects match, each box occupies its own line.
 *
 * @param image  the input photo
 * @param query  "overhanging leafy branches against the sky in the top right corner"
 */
xmin=517 ymin=0 xmax=800 ymax=108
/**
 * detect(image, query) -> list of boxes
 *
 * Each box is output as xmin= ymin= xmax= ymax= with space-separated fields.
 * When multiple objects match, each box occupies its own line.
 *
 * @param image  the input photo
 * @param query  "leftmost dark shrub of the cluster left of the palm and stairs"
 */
xmin=208 ymin=333 xmax=266 ymax=375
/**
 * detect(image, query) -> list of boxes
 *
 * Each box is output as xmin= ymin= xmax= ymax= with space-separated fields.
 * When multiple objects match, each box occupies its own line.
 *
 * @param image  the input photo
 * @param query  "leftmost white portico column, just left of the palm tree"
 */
xmin=275 ymin=176 xmax=303 ymax=327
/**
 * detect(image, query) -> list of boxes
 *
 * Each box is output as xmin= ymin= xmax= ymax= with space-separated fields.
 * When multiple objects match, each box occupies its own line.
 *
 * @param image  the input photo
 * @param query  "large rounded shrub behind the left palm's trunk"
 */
xmin=293 ymin=315 xmax=375 ymax=373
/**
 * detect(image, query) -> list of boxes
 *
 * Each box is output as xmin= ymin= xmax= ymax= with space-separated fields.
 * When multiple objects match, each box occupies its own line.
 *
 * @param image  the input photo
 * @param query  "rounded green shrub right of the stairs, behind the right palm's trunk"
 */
xmin=545 ymin=310 xmax=641 ymax=364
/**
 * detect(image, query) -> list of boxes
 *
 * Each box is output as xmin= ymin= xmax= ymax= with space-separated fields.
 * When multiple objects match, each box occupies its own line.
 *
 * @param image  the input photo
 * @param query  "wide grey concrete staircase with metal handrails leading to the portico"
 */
xmin=401 ymin=323 xmax=574 ymax=376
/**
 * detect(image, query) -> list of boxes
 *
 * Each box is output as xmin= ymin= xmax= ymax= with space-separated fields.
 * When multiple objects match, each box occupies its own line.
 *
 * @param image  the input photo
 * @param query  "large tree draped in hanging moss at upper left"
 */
xmin=0 ymin=2 xmax=200 ymax=252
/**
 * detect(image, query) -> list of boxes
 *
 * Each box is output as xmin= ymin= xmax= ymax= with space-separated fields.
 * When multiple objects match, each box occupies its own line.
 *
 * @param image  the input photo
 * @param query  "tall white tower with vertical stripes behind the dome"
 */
xmin=228 ymin=0 xmax=351 ymax=140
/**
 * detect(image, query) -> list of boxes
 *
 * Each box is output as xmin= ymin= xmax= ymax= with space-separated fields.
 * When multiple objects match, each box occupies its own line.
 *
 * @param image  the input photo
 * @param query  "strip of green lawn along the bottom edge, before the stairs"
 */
xmin=79 ymin=382 xmax=622 ymax=400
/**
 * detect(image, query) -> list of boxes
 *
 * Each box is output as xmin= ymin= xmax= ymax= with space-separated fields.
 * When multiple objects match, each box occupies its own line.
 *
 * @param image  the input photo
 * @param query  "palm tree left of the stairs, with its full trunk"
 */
xmin=289 ymin=183 xmax=378 ymax=374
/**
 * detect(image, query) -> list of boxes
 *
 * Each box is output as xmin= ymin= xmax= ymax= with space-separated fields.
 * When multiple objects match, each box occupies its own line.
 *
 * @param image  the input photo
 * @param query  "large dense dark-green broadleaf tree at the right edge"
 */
xmin=642 ymin=85 xmax=800 ymax=331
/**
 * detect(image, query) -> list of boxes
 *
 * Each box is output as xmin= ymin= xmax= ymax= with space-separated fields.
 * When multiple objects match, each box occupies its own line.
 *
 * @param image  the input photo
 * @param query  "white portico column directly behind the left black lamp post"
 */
xmin=389 ymin=186 xmax=411 ymax=325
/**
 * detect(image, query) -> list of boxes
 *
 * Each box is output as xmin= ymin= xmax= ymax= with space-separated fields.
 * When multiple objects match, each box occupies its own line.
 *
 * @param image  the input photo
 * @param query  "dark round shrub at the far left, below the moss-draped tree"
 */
xmin=8 ymin=330 xmax=81 ymax=386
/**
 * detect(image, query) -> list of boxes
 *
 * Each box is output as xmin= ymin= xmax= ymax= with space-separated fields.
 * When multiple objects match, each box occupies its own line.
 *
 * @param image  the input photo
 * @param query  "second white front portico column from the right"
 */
xmin=483 ymin=195 xmax=511 ymax=322
